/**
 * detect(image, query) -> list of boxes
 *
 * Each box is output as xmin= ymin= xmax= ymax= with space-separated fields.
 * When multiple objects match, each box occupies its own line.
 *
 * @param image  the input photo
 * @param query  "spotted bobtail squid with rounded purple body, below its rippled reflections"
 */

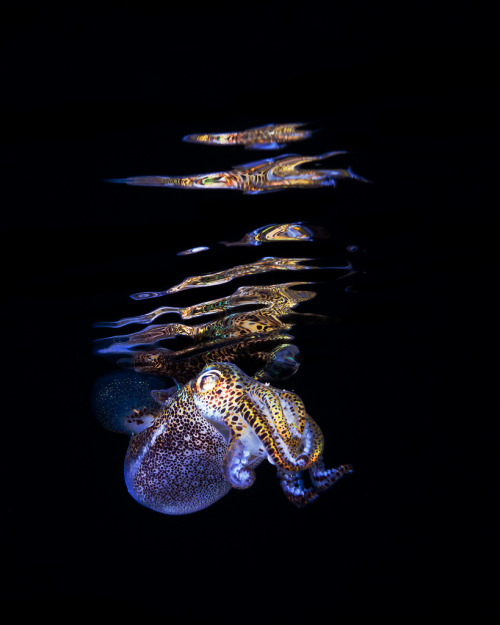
xmin=125 ymin=362 xmax=352 ymax=514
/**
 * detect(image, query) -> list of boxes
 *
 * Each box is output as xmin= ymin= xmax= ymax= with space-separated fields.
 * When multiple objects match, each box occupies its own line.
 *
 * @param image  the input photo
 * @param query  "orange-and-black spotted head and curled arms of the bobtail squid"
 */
xmin=190 ymin=362 xmax=352 ymax=505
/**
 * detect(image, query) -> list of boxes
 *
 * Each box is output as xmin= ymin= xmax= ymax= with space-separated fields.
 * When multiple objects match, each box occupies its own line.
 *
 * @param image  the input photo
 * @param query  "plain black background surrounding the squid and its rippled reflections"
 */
xmin=1 ymin=1 xmax=498 ymax=622
